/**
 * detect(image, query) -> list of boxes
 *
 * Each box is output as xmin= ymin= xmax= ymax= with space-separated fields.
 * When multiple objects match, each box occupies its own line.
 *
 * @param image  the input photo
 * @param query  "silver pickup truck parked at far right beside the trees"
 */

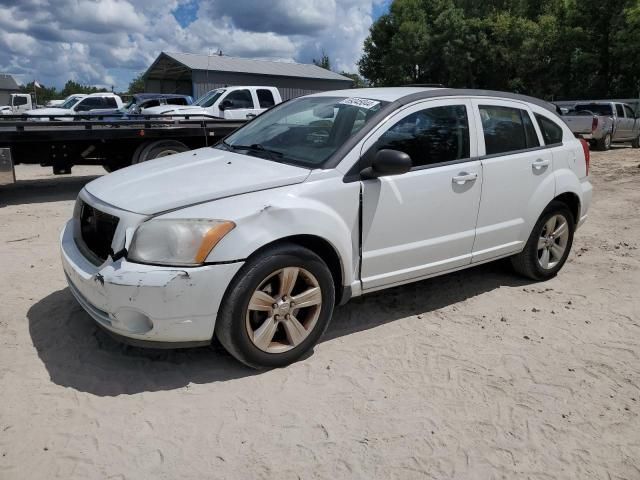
xmin=562 ymin=102 xmax=640 ymax=150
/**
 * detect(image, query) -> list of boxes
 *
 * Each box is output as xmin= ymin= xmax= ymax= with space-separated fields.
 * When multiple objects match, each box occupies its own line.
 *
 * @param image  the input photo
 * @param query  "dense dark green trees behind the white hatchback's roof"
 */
xmin=358 ymin=0 xmax=640 ymax=99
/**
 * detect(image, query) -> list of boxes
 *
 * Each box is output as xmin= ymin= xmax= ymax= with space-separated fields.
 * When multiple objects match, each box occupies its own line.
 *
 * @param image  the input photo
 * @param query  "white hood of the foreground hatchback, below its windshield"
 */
xmin=85 ymin=147 xmax=310 ymax=215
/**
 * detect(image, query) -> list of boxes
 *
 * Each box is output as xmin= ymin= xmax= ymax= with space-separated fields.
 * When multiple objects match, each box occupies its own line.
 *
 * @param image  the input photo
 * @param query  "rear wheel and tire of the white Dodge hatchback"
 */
xmin=511 ymin=201 xmax=575 ymax=281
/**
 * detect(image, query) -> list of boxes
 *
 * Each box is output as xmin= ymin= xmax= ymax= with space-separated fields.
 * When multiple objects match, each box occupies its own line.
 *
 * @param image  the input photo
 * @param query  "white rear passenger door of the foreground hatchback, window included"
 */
xmin=472 ymin=99 xmax=555 ymax=262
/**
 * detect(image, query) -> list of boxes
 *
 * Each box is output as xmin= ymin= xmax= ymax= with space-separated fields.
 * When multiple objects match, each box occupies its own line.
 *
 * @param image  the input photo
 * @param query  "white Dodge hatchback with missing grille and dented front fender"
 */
xmin=61 ymin=88 xmax=592 ymax=368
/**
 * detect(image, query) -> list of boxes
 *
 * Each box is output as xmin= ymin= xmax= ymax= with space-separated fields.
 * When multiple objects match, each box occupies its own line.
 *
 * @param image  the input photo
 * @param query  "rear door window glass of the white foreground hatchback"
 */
xmin=479 ymin=105 xmax=540 ymax=155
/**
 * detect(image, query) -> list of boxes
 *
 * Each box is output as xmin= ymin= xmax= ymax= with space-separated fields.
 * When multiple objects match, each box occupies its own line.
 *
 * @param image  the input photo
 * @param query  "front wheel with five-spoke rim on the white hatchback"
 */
xmin=215 ymin=244 xmax=335 ymax=369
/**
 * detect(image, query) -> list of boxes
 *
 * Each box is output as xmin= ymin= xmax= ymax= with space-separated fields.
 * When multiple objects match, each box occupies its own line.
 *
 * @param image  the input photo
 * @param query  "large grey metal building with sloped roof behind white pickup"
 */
xmin=144 ymin=52 xmax=353 ymax=100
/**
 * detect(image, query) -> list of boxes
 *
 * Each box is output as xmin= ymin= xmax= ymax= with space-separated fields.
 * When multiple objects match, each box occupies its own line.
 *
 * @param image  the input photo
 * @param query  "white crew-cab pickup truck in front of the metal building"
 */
xmin=142 ymin=86 xmax=282 ymax=120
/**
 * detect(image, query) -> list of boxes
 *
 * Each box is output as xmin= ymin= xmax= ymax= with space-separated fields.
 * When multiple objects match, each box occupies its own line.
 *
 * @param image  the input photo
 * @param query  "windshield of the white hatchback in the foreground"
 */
xmin=218 ymin=97 xmax=387 ymax=168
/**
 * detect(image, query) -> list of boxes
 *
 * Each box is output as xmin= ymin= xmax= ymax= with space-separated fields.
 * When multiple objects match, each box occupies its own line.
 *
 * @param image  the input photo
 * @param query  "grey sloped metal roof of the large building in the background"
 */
xmin=152 ymin=52 xmax=353 ymax=82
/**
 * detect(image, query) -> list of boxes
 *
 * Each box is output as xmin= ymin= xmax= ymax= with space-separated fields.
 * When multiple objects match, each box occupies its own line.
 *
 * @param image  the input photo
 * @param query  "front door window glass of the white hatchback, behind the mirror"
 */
xmin=375 ymin=105 xmax=469 ymax=167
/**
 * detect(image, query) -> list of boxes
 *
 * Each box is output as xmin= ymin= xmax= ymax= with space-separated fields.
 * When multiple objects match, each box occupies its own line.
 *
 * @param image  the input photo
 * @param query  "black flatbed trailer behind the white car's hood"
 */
xmin=0 ymin=115 xmax=245 ymax=185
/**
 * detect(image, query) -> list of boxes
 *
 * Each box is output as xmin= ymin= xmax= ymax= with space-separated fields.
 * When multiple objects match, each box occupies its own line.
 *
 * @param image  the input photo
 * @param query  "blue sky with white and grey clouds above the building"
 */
xmin=0 ymin=0 xmax=391 ymax=91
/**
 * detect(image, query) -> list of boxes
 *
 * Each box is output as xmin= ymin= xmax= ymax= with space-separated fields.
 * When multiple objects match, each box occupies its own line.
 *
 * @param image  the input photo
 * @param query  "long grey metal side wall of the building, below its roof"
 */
xmin=192 ymin=70 xmax=351 ymax=100
